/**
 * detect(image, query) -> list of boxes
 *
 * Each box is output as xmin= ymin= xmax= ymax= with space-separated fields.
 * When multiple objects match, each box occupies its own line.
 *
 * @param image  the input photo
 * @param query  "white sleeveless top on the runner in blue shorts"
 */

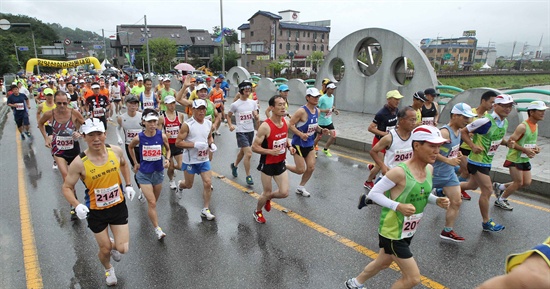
xmin=183 ymin=118 xmax=212 ymax=164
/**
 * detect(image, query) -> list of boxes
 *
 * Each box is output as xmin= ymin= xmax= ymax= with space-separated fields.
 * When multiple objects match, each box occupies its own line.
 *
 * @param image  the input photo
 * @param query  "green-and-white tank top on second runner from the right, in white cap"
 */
xmin=468 ymin=114 xmax=508 ymax=165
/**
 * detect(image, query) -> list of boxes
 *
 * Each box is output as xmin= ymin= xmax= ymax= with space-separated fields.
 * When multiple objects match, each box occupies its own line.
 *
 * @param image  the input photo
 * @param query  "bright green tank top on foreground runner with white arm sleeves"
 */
xmin=378 ymin=163 xmax=432 ymax=240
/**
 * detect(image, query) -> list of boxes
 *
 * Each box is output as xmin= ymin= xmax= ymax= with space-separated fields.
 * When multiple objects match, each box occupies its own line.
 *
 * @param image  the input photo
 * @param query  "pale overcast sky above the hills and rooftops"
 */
xmin=0 ymin=0 xmax=550 ymax=56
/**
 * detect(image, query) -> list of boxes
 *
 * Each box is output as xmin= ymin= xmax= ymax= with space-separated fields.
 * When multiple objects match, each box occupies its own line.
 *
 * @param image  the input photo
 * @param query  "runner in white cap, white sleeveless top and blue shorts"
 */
xmin=176 ymin=99 xmax=217 ymax=221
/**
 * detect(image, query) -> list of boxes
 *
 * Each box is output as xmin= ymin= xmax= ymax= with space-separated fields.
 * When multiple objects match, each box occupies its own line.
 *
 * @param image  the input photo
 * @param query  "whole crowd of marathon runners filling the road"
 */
xmin=7 ymin=75 xmax=548 ymax=288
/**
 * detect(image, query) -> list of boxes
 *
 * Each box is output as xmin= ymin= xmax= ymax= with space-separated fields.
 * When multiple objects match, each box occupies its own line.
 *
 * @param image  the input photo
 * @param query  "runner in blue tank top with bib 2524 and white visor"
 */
xmin=128 ymin=108 xmax=170 ymax=240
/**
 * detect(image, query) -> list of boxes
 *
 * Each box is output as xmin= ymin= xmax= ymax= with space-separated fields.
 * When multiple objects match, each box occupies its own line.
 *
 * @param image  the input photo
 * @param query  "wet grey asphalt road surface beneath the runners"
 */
xmin=0 ymin=110 xmax=550 ymax=288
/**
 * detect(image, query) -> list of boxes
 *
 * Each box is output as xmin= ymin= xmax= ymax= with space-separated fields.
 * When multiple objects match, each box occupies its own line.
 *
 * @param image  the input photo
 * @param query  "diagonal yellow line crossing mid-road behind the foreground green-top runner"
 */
xmin=212 ymin=171 xmax=447 ymax=289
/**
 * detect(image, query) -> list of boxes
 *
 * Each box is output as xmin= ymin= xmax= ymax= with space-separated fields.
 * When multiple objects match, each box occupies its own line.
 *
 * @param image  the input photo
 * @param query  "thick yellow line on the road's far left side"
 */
xmin=15 ymin=131 xmax=44 ymax=289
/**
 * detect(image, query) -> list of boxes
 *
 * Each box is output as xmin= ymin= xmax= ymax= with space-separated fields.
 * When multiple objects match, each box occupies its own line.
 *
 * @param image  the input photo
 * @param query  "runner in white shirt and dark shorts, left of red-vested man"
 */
xmin=227 ymin=80 xmax=260 ymax=186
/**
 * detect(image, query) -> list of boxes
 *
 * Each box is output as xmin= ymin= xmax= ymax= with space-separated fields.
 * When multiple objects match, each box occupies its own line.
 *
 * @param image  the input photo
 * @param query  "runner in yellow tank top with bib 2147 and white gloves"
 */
xmin=62 ymin=118 xmax=135 ymax=286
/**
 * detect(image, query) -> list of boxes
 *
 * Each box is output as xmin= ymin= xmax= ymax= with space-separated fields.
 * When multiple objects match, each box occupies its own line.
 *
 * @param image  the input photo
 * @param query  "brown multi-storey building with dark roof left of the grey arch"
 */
xmin=238 ymin=10 xmax=330 ymax=76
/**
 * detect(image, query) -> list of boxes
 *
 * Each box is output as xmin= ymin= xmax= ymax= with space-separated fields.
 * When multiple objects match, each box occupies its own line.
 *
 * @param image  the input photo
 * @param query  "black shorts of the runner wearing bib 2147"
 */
xmin=88 ymin=199 xmax=128 ymax=234
